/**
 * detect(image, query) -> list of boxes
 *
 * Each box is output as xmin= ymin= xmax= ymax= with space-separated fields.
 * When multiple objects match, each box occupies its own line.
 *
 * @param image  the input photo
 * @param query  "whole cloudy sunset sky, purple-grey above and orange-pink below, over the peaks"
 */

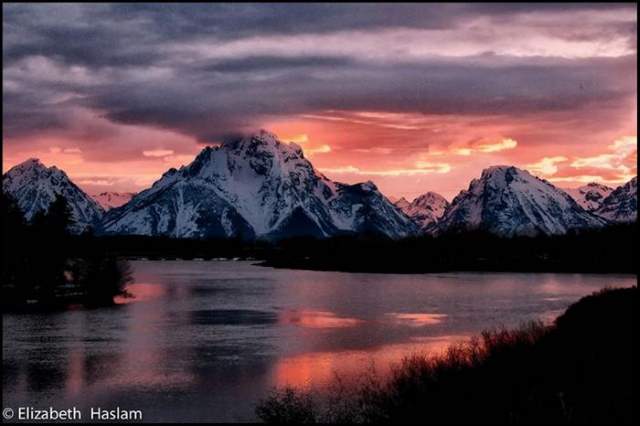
xmin=2 ymin=3 xmax=637 ymax=200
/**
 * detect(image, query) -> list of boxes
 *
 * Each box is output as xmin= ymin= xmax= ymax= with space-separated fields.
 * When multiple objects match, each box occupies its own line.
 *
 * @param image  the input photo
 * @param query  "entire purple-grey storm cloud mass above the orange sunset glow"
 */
xmin=3 ymin=4 xmax=637 ymax=141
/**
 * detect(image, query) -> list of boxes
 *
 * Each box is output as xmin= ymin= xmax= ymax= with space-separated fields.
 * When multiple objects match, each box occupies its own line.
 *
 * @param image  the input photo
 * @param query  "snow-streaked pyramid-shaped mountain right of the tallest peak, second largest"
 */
xmin=435 ymin=166 xmax=606 ymax=236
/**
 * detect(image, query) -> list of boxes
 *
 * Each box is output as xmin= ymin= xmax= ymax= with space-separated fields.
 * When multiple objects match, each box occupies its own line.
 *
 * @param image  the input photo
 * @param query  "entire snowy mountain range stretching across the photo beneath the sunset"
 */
xmin=2 ymin=131 xmax=637 ymax=239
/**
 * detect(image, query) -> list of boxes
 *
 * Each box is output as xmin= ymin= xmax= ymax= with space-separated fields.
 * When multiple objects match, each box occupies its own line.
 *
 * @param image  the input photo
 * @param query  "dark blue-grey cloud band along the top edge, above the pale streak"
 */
xmin=3 ymin=3 xmax=635 ymax=66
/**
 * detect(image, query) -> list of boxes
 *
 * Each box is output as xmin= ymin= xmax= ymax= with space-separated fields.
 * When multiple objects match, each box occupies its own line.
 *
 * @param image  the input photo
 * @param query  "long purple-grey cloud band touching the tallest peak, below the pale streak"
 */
xmin=66 ymin=58 xmax=635 ymax=142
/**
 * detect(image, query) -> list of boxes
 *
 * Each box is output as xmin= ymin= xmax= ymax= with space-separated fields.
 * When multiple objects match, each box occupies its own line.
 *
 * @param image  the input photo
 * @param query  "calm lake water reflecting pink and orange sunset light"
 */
xmin=2 ymin=261 xmax=636 ymax=421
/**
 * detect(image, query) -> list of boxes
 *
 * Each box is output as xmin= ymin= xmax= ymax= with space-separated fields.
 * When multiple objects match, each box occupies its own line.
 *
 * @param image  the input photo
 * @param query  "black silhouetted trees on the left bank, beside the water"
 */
xmin=2 ymin=193 xmax=131 ymax=309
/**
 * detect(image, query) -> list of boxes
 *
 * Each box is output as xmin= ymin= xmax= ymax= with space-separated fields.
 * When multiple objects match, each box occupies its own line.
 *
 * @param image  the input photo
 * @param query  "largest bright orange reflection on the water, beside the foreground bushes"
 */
xmin=272 ymin=335 xmax=468 ymax=388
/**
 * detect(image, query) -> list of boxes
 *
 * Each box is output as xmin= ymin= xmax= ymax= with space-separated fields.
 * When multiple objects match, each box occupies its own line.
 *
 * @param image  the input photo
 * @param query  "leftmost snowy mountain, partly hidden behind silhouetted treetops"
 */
xmin=2 ymin=158 xmax=104 ymax=232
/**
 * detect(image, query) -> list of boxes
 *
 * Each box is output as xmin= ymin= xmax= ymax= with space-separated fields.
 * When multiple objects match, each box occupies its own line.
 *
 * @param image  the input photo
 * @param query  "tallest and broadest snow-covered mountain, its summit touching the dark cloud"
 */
xmin=102 ymin=131 xmax=415 ymax=238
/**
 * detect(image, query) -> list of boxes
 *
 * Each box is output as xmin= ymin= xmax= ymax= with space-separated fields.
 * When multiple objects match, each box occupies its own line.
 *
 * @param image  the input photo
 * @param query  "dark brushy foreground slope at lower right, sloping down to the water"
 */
xmin=256 ymin=286 xmax=638 ymax=424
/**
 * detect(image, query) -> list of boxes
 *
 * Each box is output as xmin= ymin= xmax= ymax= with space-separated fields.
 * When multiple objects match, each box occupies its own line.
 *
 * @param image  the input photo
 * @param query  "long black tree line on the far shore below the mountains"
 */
xmin=43 ymin=223 xmax=637 ymax=273
